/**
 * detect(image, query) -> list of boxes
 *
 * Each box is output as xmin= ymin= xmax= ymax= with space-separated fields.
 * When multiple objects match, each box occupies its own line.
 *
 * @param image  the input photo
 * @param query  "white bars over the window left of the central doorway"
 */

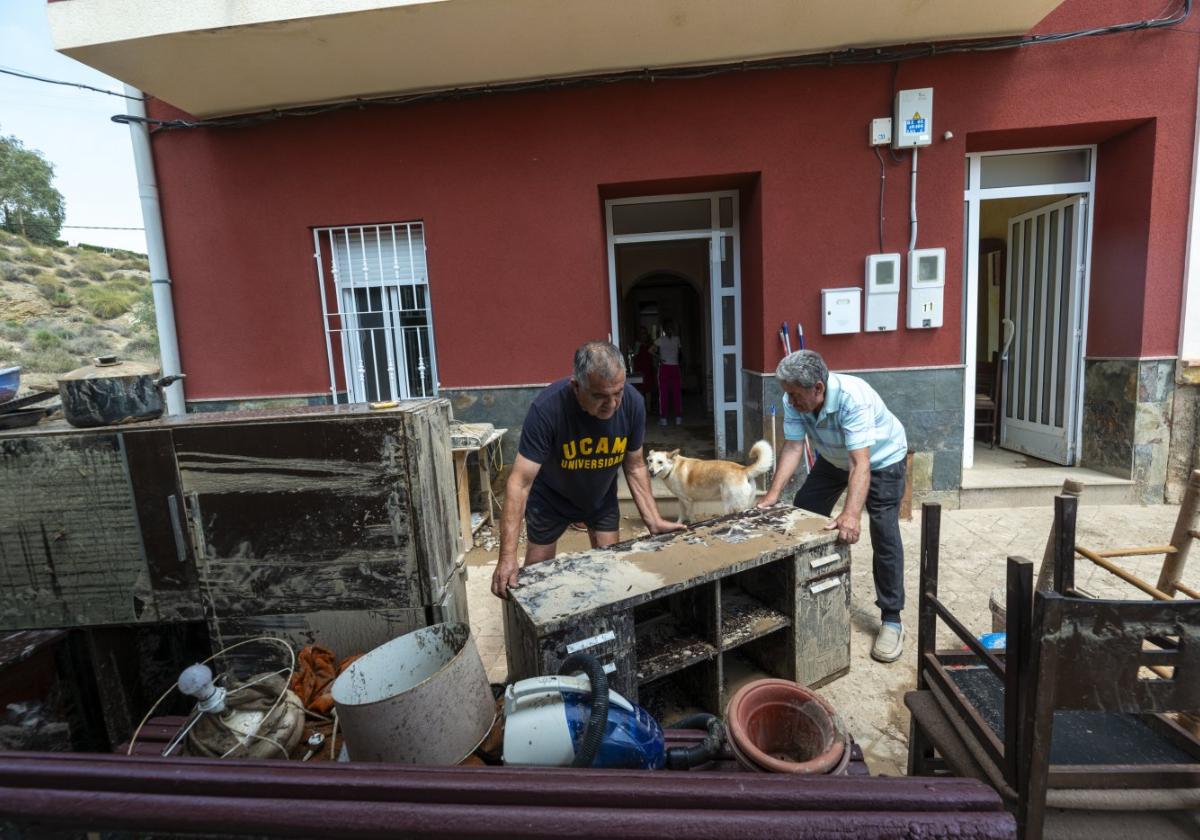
xmin=312 ymin=222 xmax=438 ymax=403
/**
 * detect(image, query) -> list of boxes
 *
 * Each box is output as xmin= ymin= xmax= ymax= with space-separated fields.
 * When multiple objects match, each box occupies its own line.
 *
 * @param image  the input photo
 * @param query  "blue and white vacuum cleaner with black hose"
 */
xmin=504 ymin=653 xmax=724 ymax=769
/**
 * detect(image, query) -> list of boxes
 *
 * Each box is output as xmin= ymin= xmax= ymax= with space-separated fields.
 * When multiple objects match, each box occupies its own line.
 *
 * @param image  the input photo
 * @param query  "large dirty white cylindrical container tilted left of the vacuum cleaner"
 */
xmin=331 ymin=624 xmax=496 ymax=764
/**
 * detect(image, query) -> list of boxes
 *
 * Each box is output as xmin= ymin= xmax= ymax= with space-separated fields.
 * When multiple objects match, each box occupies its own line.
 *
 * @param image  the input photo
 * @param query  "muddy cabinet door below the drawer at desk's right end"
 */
xmin=796 ymin=569 xmax=850 ymax=686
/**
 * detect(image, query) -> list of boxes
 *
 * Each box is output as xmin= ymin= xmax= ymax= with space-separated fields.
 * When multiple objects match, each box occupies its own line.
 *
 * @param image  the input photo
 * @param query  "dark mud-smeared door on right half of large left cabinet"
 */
xmin=174 ymin=413 xmax=428 ymax=655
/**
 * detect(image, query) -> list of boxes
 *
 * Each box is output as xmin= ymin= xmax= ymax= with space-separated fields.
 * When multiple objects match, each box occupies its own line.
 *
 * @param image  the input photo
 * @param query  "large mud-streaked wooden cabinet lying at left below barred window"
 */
xmin=0 ymin=400 xmax=467 ymax=653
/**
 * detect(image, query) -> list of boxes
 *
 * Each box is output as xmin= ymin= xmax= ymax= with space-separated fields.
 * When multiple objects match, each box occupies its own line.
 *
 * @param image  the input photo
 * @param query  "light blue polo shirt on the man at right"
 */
xmin=784 ymin=373 xmax=908 ymax=469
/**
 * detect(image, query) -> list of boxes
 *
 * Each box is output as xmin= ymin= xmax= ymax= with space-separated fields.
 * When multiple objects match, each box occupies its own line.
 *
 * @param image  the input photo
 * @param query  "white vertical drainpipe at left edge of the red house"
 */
xmin=125 ymin=85 xmax=187 ymax=414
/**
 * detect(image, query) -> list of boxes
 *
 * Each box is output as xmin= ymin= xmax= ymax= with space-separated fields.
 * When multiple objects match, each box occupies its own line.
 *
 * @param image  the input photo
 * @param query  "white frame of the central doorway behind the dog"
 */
xmin=604 ymin=190 xmax=743 ymax=455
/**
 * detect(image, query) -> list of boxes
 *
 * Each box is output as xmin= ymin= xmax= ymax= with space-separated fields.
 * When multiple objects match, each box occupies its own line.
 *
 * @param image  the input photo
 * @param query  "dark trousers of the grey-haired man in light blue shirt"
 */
xmin=792 ymin=457 xmax=905 ymax=622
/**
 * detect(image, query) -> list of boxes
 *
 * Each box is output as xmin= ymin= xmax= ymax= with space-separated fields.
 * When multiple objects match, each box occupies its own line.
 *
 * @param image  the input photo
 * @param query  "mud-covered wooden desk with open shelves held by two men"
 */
xmin=505 ymin=505 xmax=850 ymax=724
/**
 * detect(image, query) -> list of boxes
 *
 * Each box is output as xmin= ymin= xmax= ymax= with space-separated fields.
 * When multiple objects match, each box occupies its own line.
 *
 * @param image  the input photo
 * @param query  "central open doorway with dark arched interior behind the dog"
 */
xmin=605 ymin=192 xmax=743 ymax=457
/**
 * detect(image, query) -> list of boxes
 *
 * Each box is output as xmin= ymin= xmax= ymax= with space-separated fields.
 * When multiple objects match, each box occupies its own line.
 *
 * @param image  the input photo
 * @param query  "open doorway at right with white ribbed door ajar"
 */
xmin=964 ymin=148 xmax=1096 ymax=472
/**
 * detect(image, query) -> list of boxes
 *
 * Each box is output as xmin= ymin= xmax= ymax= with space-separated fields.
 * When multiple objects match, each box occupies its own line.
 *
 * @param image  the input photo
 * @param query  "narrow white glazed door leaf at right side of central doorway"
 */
xmin=708 ymin=233 xmax=743 ymax=458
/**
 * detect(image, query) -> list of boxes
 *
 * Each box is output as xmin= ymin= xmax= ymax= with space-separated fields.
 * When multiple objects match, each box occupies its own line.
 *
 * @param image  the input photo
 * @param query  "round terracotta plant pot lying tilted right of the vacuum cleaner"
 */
xmin=725 ymin=679 xmax=850 ymax=775
